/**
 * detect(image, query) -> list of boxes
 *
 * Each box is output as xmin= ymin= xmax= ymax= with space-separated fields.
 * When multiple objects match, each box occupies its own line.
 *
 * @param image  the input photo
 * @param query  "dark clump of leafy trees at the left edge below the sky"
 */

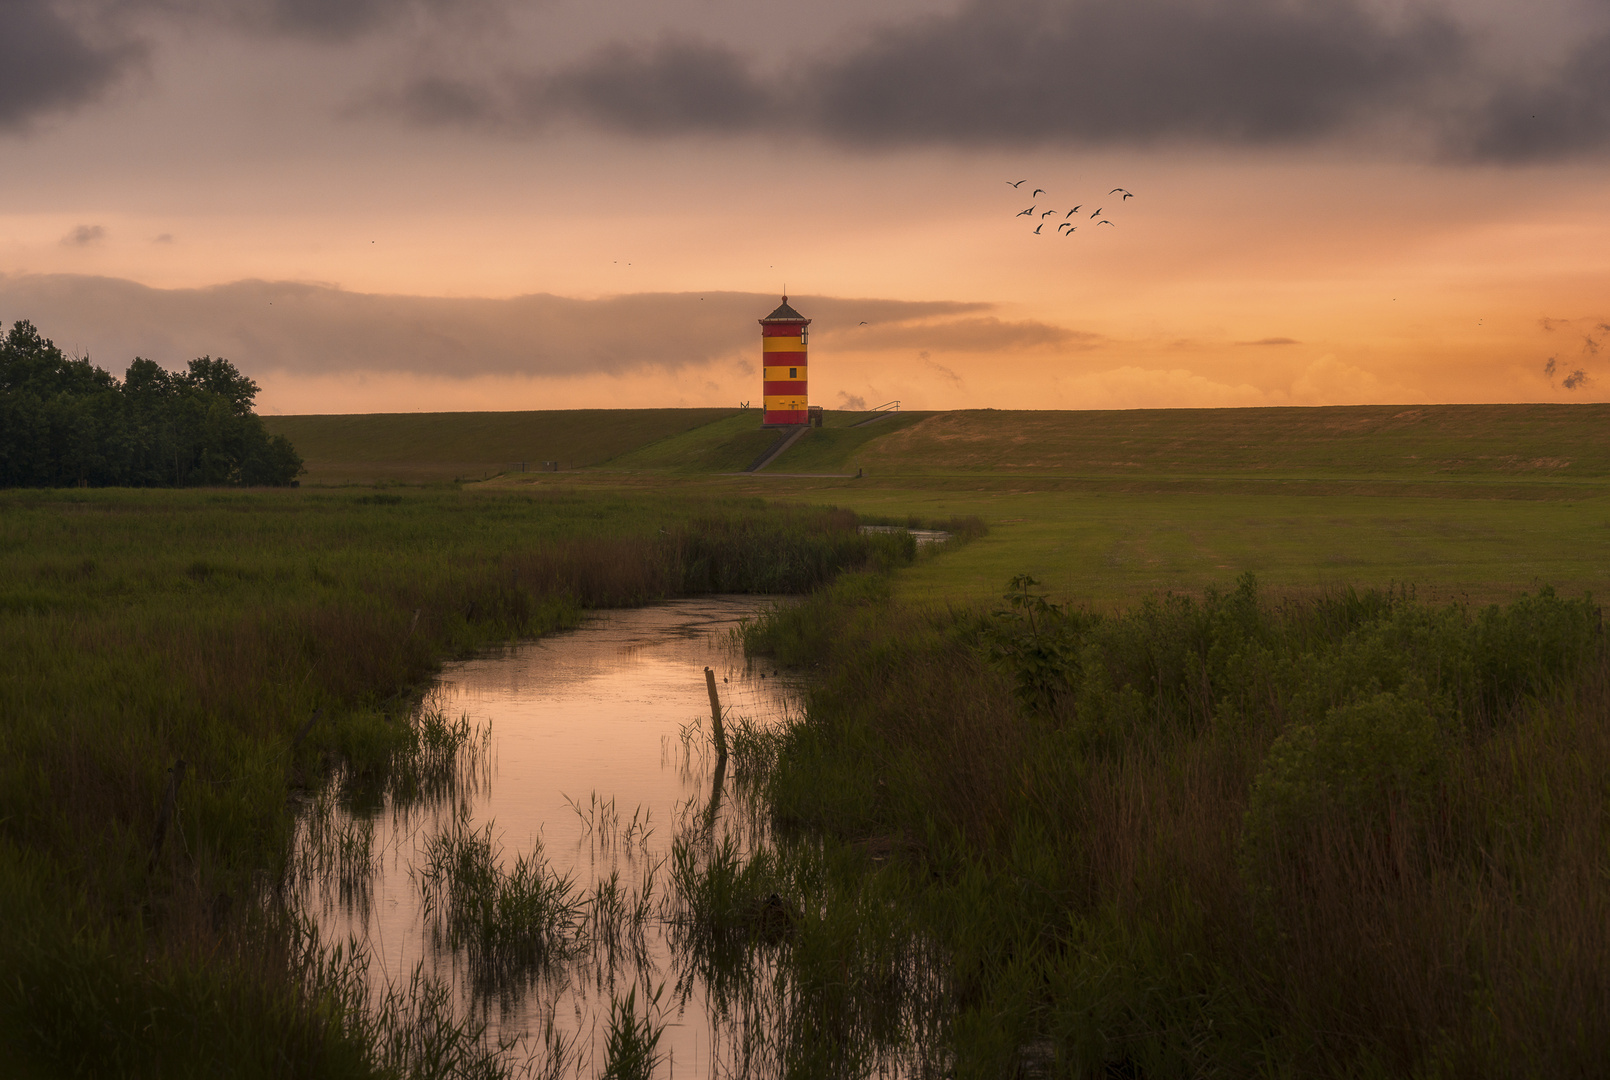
xmin=0 ymin=322 xmax=303 ymax=488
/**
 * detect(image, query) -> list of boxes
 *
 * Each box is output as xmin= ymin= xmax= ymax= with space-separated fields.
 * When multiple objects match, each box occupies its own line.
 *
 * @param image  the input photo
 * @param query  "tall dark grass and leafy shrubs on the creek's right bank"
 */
xmin=749 ymin=578 xmax=1610 ymax=1077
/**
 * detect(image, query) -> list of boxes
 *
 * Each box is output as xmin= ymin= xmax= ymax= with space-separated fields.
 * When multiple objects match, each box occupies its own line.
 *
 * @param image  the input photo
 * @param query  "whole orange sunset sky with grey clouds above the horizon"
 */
xmin=0 ymin=0 xmax=1610 ymax=412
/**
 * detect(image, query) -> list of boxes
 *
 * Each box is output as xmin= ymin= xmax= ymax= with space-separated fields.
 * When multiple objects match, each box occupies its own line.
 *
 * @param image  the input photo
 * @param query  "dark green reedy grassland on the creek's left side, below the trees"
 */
xmin=0 ymin=489 xmax=898 ymax=1077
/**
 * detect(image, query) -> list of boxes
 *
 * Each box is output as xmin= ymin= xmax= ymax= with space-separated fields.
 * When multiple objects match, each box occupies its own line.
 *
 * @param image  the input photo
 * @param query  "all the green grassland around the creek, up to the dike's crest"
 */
xmin=12 ymin=406 xmax=1610 ymax=1077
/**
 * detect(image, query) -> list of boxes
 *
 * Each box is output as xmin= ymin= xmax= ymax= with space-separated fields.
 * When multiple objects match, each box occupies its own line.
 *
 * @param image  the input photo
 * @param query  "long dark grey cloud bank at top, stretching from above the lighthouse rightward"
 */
xmin=418 ymin=0 xmax=1467 ymax=146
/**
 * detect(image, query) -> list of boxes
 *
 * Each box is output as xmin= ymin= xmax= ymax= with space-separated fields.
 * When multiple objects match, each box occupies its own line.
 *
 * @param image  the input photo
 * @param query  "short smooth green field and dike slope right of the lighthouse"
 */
xmin=421 ymin=406 xmax=1610 ymax=607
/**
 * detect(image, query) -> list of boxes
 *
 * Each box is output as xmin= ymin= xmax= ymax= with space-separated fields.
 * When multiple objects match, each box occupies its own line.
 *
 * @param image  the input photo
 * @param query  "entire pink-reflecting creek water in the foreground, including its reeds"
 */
xmin=298 ymin=597 xmax=800 ymax=1077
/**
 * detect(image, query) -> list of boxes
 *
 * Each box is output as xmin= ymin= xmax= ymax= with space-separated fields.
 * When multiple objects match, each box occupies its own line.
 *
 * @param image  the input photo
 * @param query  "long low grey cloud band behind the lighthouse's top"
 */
xmin=0 ymin=274 xmax=990 ymax=377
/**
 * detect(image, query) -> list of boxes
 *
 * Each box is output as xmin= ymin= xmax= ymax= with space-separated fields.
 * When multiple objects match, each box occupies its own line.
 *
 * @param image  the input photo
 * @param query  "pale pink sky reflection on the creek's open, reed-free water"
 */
xmin=299 ymin=597 xmax=797 ymax=1077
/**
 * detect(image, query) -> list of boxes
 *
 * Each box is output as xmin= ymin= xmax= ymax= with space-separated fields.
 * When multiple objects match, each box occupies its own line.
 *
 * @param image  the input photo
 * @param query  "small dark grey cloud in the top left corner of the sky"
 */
xmin=0 ymin=0 xmax=140 ymax=132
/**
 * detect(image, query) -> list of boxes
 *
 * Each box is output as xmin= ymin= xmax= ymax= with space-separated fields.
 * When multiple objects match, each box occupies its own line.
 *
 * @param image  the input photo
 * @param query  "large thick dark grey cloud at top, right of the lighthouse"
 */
xmin=815 ymin=0 xmax=1462 ymax=143
